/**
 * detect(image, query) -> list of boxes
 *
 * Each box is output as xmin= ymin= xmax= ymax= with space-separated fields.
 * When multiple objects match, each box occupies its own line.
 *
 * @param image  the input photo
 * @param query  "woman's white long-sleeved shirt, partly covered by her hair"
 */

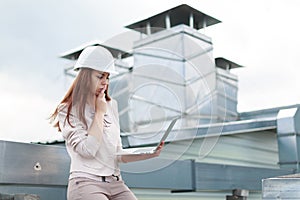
xmin=58 ymin=100 xmax=122 ymax=178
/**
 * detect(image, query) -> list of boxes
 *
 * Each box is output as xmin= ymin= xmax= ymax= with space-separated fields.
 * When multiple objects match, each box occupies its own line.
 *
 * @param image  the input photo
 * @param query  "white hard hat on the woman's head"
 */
xmin=74 ymin=46 xmax=118 ymax=74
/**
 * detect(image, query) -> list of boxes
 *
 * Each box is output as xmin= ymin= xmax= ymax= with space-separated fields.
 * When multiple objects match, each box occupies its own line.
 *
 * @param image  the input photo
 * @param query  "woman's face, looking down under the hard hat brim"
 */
xmin=91 ymin=70 xmax=109 ymax=96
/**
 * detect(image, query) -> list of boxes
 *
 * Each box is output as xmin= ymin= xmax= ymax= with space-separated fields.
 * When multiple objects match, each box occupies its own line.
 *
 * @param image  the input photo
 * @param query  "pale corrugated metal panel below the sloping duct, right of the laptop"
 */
xmin=161 ymin=131 xmax=279 ymax=168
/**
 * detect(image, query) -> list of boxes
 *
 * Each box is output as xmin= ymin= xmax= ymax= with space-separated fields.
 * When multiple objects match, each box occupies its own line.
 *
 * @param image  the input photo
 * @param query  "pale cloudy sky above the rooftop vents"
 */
xmin=0 ymin=0 xmax=300 ymax=142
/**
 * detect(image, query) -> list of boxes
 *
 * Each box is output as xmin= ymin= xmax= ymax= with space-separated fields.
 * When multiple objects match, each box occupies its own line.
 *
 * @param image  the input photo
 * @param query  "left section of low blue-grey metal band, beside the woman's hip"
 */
xmin=122 ymin=159 xmax=195 ymax=191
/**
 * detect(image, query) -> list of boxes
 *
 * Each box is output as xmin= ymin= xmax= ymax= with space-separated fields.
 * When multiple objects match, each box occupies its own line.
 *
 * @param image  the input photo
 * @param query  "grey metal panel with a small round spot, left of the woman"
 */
xmin=0 ymin=141 xmax=70 ymax=186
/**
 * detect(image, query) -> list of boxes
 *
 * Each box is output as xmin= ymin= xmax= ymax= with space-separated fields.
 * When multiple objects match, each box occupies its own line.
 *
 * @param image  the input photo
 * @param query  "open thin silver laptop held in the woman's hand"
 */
xmin=116 ymin=118 xmax=178 ymax=155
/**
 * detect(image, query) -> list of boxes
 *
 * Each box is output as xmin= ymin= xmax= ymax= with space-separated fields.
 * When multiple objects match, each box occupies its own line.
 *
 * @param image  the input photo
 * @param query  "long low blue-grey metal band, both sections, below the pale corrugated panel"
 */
xmin=122 ymin=159 xmax=293 ymax=191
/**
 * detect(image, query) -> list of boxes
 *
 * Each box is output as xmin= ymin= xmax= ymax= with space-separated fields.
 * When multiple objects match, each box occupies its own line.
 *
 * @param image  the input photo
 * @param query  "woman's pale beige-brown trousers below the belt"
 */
xmin=67 ymin=177 xmax=137 ymax=200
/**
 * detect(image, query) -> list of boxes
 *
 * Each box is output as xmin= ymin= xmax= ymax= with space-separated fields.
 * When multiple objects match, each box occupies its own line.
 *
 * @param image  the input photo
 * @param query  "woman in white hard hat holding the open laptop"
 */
xmin=50 ymin=46 xmax=163 ymax=200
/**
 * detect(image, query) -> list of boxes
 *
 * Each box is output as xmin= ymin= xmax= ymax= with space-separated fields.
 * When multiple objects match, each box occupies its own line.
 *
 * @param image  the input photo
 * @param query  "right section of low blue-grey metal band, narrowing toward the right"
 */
xmin=195 ymin=163 xmax=293 ymax=191
